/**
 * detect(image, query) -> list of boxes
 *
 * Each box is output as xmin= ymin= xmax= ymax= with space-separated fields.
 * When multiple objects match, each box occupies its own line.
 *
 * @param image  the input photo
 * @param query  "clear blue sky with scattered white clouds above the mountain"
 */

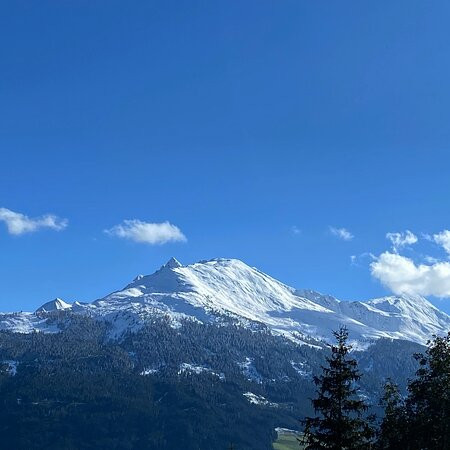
xmin=0 ymin=0 xmax=450 ymax=312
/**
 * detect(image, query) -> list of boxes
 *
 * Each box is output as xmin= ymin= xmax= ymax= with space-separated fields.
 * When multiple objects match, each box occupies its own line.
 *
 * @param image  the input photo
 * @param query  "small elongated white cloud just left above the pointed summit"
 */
xmin=105 ymin=219 xmax=187 ymax=245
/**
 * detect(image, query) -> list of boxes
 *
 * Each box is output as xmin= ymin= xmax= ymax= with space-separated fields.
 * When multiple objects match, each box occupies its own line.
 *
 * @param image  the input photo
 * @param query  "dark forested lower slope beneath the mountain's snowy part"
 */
xmin=0 ymin=315 xmax=421 ymax=450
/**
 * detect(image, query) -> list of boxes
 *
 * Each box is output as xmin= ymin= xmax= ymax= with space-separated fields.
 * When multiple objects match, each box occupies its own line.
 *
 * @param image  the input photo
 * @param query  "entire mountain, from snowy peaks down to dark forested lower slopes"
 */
xmin=0 ymin=260 xmax=450 ymax=450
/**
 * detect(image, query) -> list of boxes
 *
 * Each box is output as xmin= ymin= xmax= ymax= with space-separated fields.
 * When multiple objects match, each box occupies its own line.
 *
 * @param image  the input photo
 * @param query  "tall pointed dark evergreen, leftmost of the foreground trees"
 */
xmin=302 ymin=327 xmax=373 ymax=450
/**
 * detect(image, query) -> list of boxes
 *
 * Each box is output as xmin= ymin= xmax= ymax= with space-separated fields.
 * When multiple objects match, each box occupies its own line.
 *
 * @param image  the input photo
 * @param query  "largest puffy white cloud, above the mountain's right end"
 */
xmin=370 ymin=252 xmax=450 ymax=297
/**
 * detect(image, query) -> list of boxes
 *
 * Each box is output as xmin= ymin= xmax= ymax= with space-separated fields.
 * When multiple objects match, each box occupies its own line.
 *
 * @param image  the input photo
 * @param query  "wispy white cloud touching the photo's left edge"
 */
xmin=0 ymin=208 xmax=69 ymax=235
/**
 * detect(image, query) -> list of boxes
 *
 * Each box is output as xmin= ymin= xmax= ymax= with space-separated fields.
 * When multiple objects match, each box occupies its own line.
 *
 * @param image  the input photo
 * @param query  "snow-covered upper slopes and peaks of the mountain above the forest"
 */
xmin=0 ymin=258 xmax=450 ymax=343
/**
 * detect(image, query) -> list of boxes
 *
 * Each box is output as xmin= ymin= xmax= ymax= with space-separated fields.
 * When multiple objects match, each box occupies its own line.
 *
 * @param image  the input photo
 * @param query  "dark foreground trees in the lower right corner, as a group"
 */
xmin=300 ymin=328 xmax=450 ymax=450
